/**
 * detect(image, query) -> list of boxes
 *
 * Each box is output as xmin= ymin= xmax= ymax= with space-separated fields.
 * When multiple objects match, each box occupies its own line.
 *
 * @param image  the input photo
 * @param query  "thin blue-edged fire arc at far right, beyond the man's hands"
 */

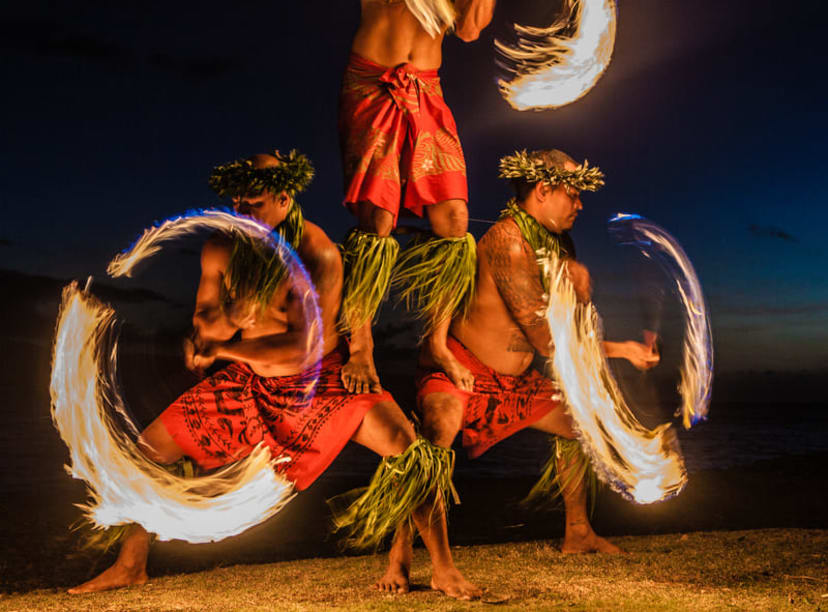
xmin=610 ymin=213 xmax=713 ymax=429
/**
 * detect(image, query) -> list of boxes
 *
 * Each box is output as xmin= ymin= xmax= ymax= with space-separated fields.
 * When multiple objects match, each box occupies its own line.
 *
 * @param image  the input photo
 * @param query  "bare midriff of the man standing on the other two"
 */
xmin=351 ymin=0 xmax=443 ymax=70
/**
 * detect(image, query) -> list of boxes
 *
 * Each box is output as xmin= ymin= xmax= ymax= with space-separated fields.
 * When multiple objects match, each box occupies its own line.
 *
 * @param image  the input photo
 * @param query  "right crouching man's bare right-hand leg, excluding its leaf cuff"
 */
xmin=532 ymin=408 xmax=624 ymax=554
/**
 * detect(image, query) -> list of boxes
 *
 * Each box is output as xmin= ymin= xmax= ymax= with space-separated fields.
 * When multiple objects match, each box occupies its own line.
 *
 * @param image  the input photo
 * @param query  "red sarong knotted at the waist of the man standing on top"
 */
xmin=339 ymin=54 xmax=468 ymax=225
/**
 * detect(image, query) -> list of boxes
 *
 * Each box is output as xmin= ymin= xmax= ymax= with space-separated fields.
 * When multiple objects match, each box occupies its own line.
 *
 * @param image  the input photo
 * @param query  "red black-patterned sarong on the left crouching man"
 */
xmin=160 ymin=346 xmax=393 ymax=491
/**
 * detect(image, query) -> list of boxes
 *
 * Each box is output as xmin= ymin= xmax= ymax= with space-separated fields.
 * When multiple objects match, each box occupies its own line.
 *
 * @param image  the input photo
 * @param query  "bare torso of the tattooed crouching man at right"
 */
xmin=450 ymin=220 xmax=543 ymax=375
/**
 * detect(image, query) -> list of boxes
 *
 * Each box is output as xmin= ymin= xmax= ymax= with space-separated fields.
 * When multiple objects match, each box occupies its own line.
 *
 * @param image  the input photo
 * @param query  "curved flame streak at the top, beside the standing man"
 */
xmin=495 ymin=0 xmax=616 ymax=111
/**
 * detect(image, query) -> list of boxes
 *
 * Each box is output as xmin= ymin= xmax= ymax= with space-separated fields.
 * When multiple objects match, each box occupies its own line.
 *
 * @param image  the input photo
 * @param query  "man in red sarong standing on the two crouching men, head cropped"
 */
xmin=339 ymin=0 xmax=495 ymax=393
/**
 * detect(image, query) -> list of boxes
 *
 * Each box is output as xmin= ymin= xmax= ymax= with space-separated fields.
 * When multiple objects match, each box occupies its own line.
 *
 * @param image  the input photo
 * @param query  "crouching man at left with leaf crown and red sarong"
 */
xmin=69 ymin=152 xmax=475 ymax=597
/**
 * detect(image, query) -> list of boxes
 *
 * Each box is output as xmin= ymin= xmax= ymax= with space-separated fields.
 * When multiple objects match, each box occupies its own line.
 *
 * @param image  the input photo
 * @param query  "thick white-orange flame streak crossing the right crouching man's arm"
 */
xmin=540 ymin=253 xmax=687 ymax=504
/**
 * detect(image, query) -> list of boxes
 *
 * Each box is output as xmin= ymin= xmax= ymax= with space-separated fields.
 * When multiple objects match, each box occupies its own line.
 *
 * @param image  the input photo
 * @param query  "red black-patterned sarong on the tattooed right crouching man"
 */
xmin=417 ymin=336 xmax=563 ymax=459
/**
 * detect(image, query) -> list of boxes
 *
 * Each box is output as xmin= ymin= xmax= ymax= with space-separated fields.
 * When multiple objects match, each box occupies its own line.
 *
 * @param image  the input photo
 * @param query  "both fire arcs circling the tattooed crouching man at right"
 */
xmin=541 ymin=215 xmax=712 ymax=504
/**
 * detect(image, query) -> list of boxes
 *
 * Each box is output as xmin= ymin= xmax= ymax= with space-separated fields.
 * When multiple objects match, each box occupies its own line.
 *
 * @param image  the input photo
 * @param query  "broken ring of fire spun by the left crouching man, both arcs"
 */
xmin=51 ymin=211 xmax=322 ymax=543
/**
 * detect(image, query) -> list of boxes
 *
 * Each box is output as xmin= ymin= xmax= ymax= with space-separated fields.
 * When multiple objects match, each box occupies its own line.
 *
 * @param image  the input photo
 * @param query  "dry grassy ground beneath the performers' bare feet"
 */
xmin=0 ymin=529 xmax=828 ymax=611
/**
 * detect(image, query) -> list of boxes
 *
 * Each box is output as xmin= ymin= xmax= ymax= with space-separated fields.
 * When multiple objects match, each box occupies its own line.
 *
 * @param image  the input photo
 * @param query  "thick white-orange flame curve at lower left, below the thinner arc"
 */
xmin=51 ymin=283 xmax=293 ymax=542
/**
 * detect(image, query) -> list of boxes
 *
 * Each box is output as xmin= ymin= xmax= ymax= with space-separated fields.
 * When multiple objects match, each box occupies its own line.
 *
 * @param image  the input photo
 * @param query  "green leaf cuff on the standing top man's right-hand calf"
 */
xmin=391 ymin=233 xmax=477 ymax=336
